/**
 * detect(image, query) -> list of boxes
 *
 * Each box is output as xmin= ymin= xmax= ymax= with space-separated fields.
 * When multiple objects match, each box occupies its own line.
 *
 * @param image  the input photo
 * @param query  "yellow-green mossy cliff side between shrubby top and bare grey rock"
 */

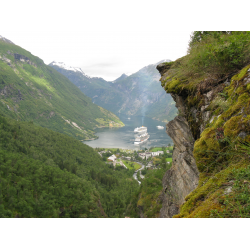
xmin=161 ymin=59 xmax=250 ymax=218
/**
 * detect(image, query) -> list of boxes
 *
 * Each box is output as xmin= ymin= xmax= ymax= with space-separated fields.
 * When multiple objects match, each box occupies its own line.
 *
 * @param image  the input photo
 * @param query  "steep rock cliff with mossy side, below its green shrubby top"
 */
xmin=157 ymin=32 xmax=250 ymax=218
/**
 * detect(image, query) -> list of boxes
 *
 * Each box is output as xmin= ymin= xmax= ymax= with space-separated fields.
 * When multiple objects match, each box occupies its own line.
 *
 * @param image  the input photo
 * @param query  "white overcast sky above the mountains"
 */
xmin=0 ymin=31 xmax=191 ymax=81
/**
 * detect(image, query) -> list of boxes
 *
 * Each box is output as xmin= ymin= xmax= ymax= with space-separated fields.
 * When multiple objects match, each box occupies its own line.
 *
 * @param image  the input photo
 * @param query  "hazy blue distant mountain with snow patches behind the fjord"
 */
xmin=49 ymin=59 xmax=177 ymax=122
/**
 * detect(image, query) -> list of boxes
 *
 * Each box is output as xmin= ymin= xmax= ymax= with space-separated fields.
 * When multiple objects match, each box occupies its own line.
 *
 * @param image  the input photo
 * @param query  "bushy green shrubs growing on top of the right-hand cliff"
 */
xmin=175 ymin=31 xmax=250 ymax=81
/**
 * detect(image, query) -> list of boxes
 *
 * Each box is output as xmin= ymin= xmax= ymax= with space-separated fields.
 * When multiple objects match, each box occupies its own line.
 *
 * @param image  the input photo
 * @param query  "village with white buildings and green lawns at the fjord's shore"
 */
xmin=95 ymin=146 xmax=173 ymax=184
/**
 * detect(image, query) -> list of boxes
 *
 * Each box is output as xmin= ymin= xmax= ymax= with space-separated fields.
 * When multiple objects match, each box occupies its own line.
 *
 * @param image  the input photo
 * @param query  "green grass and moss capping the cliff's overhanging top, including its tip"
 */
xmin=161 ymin=31 xmax=250 ymax=100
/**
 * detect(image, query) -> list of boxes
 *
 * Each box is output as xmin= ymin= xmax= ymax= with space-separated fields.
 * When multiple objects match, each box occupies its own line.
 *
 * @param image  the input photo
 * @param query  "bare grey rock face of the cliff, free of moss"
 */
xmin=157 ymin=64 xmax=199 ymax=218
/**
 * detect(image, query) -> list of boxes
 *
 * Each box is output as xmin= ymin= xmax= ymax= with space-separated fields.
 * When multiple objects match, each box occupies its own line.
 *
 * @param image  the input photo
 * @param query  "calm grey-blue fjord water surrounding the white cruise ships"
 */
xmin=84 ymin=115 xmax=173 ymax=150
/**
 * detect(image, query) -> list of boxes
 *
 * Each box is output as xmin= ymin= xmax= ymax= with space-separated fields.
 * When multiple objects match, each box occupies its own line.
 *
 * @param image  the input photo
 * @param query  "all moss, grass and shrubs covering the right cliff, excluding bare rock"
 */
xmin=158 ymin=31 xmax=250 ymax=218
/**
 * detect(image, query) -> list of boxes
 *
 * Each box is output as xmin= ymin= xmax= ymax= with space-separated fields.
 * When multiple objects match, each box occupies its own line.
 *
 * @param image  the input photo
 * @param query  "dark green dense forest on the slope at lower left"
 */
xmin=0 ymin=116 xmax=139 ymax=218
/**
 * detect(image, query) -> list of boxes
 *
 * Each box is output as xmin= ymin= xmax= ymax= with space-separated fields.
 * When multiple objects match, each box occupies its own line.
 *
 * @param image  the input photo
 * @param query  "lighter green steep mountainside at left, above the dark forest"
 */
xmin=0 ymin=36 xmax=124 ymax=140
